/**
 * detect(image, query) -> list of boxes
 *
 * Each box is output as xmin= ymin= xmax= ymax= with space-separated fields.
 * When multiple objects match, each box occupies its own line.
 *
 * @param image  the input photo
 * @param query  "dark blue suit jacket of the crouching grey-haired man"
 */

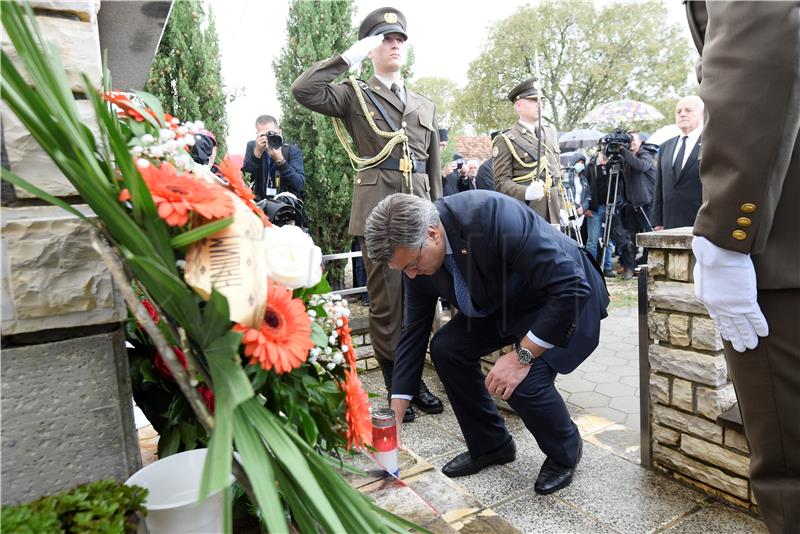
xmin=392 ymin=190 xmax=609 ymax=394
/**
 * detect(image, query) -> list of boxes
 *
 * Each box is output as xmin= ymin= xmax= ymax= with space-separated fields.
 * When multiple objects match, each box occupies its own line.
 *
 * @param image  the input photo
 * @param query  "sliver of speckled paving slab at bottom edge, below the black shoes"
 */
xmin=496 ymin=494 xmax=614 ymax=534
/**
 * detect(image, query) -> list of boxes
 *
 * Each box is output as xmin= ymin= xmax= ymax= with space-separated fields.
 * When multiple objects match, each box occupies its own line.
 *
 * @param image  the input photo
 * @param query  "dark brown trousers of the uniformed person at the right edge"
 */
xmin=724 ymin=289 xmax=800 ymax=534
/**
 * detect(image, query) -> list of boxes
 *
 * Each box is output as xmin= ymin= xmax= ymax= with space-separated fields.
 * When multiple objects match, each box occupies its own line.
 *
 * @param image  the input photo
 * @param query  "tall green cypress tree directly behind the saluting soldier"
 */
xmin=273 ymin=0 xmax=355 ymax=288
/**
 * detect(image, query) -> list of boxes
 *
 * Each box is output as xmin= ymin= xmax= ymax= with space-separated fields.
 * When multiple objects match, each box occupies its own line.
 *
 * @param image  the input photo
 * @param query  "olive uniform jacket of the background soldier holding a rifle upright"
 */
xmin=492 ymin=123 xmax=561 ymax=223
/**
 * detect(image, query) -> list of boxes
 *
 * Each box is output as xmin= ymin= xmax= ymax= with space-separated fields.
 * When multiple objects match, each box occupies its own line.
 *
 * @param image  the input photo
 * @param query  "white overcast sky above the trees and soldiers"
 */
xmin=212 ymin=0 xmax=690 ymax=154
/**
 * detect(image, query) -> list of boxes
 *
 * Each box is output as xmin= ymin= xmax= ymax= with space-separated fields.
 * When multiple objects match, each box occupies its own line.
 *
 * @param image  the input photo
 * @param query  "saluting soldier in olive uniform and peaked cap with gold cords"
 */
xmin=292 ymin=4 xmax=443 ymax=421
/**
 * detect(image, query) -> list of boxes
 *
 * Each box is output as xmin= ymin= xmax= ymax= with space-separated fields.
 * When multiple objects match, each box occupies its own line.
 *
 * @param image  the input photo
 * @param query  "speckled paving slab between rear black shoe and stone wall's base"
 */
xmin=556 ymin=443 xmax=702 ymax=534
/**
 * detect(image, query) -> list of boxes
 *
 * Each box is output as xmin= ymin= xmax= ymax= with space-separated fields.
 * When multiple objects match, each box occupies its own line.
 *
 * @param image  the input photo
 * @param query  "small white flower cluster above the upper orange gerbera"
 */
xmin=131 ymin=118 xmax=204 ymax=172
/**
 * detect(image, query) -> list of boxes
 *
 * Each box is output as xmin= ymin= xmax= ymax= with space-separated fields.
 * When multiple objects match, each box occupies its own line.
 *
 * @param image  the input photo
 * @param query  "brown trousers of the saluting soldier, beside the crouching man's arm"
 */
xmin=358 ymin=236 xmax=403 ymax=368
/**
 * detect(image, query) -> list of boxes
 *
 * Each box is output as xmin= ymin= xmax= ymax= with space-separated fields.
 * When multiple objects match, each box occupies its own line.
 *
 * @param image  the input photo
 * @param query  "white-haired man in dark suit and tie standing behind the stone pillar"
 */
xmin=652 ymin=95 xmax=703 ymax=230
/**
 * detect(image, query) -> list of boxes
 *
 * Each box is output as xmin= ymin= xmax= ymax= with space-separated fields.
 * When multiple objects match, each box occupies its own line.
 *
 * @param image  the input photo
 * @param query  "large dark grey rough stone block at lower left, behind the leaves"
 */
xmin=0 ymin=330 xmax=141 ymax=504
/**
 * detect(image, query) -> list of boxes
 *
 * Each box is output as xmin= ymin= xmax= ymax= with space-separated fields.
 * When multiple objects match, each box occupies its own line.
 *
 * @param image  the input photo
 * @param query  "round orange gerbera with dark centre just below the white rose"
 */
xmin=234 ymin=280 xmax=314 ymax=374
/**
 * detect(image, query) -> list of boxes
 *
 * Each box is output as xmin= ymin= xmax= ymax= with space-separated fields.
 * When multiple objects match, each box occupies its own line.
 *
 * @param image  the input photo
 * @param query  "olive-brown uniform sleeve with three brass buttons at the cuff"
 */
xmin=694 ymin=2 xmax=800 ymax=254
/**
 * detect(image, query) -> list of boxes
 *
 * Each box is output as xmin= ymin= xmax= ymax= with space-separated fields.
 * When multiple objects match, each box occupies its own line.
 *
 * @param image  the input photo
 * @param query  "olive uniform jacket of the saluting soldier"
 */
xmin=292 ymin=55 xmax=442 ymax=235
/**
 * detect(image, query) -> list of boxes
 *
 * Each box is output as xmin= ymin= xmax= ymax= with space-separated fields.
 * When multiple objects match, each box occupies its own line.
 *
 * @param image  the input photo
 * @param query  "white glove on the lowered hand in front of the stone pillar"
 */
xmin=692 ymin=236 xmax=769 ymax=352
